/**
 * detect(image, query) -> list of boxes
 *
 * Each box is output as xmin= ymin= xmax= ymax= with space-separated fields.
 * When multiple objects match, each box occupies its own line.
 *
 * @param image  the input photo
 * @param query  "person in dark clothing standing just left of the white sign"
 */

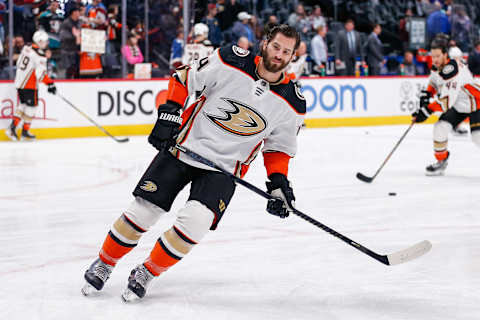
xmin=59 ymin=7 xmax=80 ymax=79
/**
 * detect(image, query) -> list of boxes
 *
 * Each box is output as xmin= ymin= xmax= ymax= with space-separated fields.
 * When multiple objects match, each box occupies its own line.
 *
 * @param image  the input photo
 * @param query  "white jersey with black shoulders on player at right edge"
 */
xmin=429 ymin=59 xmax=480 ymax=113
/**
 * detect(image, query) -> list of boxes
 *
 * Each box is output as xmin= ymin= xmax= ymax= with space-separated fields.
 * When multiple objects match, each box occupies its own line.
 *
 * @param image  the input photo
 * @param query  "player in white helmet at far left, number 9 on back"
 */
xmin=5 ymin=30 xmax=57 ymax=141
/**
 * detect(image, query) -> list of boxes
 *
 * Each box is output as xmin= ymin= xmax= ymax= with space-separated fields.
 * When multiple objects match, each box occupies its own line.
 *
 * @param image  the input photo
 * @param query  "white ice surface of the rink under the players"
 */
xmin=0 ymin=125 xmax=480 ymax=320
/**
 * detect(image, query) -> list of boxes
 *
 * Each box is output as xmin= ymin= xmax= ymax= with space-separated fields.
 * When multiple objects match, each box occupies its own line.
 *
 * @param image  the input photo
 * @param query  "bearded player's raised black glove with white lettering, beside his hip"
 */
xmin=148 ymin=102 xmax=182 ymax=151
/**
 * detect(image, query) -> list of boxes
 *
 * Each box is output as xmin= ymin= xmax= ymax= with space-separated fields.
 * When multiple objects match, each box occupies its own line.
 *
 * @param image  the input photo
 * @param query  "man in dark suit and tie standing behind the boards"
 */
xmin=335 ymin=19 xmax=364 ymax=76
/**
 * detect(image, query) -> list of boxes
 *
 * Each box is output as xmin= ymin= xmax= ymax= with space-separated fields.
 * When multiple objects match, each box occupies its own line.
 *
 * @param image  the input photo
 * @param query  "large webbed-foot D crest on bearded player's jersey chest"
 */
xmin=204 ymin=98 xmax=267 ymax=137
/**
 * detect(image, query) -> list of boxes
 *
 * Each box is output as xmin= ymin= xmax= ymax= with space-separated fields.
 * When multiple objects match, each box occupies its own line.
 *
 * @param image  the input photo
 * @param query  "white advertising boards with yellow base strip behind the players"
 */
xmin=0 ymin=77 xmax=434 ymax=140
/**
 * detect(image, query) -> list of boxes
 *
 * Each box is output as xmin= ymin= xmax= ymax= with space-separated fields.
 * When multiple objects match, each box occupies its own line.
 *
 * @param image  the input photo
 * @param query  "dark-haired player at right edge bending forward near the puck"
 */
xmin=412 ymin=38 xmax=480 ymax=175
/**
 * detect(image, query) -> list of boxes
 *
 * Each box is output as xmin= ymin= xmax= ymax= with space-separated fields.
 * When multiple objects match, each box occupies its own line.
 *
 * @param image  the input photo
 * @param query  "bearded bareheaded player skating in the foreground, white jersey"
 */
xmin=82 ymin=25 xmax=306 ymax=301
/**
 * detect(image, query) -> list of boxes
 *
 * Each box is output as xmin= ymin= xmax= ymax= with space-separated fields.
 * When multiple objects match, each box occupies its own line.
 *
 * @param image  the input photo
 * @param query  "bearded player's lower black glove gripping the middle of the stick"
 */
xmin=266 ymin=173 xmax=295 ymax=219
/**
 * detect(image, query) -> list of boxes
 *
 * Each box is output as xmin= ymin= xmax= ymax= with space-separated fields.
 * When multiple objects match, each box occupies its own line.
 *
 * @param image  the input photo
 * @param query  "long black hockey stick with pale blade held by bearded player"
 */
xmin=174 ymin=144 xmax=432 ymax=266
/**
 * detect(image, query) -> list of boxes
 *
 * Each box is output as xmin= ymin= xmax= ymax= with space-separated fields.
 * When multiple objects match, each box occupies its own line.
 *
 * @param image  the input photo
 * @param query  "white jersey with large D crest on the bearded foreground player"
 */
xmin=174 ymin=46 xmax=306 ymax=176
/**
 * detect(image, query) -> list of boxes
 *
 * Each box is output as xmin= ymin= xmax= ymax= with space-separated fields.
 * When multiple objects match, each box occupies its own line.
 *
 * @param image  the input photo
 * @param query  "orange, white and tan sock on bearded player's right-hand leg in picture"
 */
xmin=144 ymin=227 xmax=196 ymax=277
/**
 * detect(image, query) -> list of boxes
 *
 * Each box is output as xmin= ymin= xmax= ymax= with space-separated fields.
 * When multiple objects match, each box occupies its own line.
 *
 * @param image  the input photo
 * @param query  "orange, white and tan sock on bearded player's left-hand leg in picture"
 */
xmin=99 ymin=214 xmax=146 ymax=266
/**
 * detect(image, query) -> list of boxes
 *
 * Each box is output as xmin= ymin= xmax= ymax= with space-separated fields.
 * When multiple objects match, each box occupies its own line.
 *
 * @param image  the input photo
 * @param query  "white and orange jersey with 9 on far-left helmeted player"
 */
xmin=15 ymin=45 xmax=53 ymax=90
